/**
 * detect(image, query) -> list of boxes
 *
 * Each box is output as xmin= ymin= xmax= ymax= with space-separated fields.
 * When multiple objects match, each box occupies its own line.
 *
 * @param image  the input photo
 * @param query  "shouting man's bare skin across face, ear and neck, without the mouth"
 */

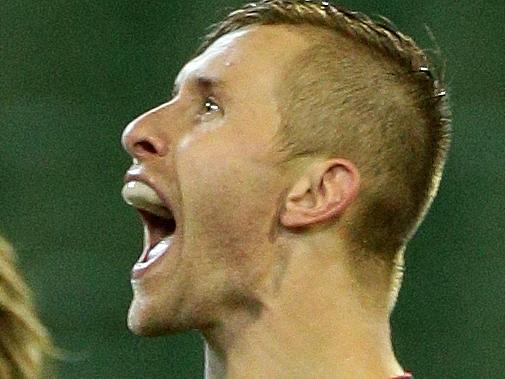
xmin=123 ymin=26 xmax=403 ymax=379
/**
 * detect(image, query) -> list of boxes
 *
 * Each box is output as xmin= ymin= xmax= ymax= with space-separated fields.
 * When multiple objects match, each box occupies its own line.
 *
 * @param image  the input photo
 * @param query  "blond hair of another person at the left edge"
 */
xmin=0 ymin=237 xmax=53 ymax=379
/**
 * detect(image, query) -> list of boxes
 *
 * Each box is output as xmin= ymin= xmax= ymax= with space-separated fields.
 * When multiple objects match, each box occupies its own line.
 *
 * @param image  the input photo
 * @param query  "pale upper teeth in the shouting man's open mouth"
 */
xmin=122 ymin=181 xmax=173 ymax=219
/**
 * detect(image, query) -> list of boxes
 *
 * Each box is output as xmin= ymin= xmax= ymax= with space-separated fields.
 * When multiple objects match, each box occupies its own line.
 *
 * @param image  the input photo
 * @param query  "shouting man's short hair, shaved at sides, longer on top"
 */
xmin=198 ymin=0 xmax=450 ymax=263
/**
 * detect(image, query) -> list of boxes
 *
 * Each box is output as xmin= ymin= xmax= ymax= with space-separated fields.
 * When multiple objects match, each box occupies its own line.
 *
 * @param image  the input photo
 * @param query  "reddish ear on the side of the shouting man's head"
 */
xmin=280 ymin=159 xmax=359 ymax=228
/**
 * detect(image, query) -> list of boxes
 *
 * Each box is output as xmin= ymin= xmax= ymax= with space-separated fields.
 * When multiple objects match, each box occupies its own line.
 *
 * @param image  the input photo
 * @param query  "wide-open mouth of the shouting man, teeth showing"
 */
xmin=122 ymin=181 xmax=177 ymax=271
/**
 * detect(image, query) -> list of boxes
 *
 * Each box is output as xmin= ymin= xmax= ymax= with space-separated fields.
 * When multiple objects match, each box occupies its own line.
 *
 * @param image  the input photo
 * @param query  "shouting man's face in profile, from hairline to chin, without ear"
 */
xmin=123 ymin=26 xmax=303 ymax=335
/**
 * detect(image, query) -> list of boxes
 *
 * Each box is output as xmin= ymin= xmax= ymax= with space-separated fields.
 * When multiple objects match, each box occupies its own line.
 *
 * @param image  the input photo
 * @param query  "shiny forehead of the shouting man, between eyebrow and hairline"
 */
xmin=176 ymin=25 xmax=307 ymax=92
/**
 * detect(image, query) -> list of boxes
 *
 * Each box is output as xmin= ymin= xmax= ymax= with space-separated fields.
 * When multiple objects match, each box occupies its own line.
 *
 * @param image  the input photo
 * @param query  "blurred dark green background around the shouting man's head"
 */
xmin=0 ymin=0 xmax=505 ymax=379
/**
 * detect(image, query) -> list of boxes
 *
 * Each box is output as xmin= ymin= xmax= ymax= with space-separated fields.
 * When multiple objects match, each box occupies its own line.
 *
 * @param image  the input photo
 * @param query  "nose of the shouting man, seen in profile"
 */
xmin=121 ymin=104 xmax=168 ymax=159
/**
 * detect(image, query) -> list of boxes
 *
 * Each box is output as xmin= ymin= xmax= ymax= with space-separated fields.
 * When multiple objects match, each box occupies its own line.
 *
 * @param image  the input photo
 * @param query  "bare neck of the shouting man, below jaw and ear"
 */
xmin=201 ymin=239 xmax=403 ymax=379
